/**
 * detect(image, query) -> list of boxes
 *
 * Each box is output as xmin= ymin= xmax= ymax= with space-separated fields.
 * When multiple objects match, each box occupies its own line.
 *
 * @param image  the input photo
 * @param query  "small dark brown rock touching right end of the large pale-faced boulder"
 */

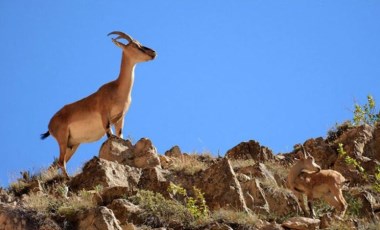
xmin=138 ymin=167 xmax=170 ymax=197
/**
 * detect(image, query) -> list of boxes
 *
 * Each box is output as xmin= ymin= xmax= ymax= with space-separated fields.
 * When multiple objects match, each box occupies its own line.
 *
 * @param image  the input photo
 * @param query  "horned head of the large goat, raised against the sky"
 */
xmin=108 ymin=31 xmax=157 ymax=62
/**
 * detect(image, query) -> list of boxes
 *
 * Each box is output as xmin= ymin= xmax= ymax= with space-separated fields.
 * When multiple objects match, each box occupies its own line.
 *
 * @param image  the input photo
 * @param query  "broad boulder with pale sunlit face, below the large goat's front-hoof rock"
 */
xmin=69 ymin=157 xmax=141 ymax=192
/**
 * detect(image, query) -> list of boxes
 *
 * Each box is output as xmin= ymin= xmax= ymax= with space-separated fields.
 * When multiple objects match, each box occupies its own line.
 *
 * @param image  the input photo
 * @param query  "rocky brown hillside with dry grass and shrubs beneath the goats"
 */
xmin=0 ymin=124 xmax=380 ymax=230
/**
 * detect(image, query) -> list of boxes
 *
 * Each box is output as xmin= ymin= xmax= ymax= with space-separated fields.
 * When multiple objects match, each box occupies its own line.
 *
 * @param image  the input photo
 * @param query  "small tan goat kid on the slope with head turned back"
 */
xmin=287 ymin=151 xmax=347 ymax=218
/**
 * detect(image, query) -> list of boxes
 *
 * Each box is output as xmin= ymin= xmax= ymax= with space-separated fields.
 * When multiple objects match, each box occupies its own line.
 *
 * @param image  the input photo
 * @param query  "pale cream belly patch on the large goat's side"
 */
xmin=69 ymin=114 xmax=106 ymax=145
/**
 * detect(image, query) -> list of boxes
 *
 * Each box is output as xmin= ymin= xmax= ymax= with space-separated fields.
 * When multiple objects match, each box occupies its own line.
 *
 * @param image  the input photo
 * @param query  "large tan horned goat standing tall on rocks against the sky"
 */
xmin=41 ymin=31 xmax=156 ymax=178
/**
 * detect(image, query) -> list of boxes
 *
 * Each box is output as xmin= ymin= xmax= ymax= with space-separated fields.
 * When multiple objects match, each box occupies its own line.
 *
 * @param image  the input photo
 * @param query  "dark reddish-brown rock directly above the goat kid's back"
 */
xmin=303 ymin=137 xmax=338 ymax=169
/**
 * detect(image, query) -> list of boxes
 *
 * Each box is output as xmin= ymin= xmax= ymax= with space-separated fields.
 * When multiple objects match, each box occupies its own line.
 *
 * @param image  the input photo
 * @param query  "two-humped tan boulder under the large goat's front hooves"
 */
xmin=99 ymin=136 xmax=160 ymax=168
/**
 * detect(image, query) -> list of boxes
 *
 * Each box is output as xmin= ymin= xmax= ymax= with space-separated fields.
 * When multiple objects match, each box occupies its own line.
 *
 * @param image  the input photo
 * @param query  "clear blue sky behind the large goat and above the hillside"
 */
xmin=0 ymin=0 xmax=380 ymax=186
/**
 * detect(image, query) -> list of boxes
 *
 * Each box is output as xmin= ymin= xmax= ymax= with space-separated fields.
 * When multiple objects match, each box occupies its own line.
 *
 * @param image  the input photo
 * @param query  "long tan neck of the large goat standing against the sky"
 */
xmin=116 ymin=52 xmax=136 ymax=98
